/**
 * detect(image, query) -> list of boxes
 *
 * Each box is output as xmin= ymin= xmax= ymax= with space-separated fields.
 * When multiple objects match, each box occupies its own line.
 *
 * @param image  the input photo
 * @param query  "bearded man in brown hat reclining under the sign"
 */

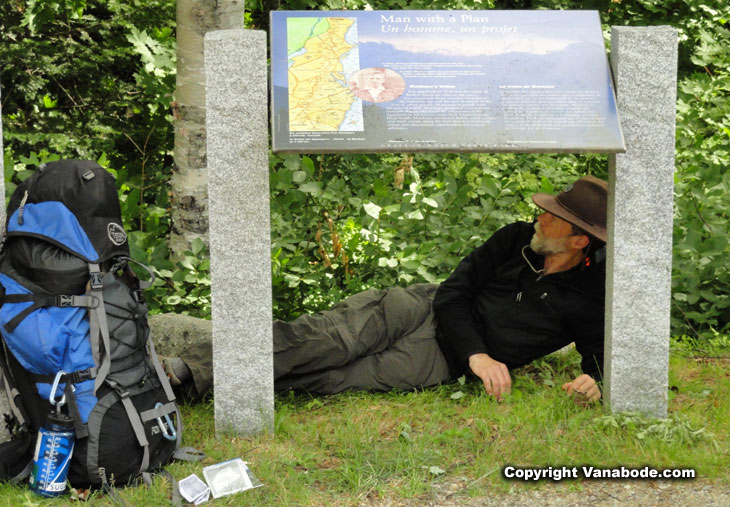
xmin=164 ymin=176 xmax=607 ymax=402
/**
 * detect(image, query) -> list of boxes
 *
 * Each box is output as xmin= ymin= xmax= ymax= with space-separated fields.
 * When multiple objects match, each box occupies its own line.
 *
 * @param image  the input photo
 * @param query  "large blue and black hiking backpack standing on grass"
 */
xmin=0 ymin=160 xmax=182 ymax=488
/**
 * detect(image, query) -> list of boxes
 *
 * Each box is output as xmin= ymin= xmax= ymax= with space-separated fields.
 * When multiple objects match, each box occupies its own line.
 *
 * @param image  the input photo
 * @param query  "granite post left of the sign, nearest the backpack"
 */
xmin=205 ymin=29 xmax=274 ymax=435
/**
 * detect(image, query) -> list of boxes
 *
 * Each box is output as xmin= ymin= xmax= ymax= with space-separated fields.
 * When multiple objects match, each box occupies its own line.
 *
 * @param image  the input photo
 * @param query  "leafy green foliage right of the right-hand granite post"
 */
xmin=672 ymin=9 xmax=730 ymax=339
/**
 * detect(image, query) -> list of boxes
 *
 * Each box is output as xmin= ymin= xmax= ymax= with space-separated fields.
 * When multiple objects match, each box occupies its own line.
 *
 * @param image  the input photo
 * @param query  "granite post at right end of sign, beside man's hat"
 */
xmin=604 ymin=27 xmax=677 ymax=417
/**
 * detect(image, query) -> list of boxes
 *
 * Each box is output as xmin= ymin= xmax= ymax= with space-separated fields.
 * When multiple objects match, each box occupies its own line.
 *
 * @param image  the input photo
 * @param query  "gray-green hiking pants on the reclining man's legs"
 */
xmin=180 ymin=284 xmax=450 ymax=395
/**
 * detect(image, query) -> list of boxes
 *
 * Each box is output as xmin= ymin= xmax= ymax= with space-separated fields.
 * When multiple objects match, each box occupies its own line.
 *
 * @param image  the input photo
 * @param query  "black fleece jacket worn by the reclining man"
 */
xmin=433 ymin=222 xmax=606 ymax=380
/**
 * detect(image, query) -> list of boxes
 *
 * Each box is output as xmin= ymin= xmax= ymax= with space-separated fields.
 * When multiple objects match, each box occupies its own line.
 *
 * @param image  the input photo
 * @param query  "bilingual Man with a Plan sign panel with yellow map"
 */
xmin=271 ymin=11 xmax=624 ymax=153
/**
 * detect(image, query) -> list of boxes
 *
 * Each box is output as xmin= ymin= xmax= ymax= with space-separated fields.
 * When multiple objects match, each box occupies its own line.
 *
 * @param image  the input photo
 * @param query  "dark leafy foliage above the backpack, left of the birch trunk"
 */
xmin=0 ymin=0 xmax=175 ymax=236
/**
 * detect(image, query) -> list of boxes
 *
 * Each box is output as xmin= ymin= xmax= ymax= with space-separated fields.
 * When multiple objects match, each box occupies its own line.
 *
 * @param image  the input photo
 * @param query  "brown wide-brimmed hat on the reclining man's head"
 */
xmin=532 ymin=176 xmax=608 ymax=241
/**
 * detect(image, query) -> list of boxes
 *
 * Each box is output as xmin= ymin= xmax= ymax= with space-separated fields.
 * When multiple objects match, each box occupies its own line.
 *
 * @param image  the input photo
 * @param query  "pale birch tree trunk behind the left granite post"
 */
xmin=170 ymin=0 xmax=244 ymax=256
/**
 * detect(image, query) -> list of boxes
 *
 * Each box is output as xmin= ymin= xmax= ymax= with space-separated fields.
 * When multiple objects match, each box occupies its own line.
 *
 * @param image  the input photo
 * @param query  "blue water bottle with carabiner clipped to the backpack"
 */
xmin=29 ymin=371 xmax=76 ymax=497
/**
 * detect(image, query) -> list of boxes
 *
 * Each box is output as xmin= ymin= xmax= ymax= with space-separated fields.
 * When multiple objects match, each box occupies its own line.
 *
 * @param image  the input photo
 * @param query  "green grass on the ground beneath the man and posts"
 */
xmin=0 ymin=347 xmax=730 ymax=506
